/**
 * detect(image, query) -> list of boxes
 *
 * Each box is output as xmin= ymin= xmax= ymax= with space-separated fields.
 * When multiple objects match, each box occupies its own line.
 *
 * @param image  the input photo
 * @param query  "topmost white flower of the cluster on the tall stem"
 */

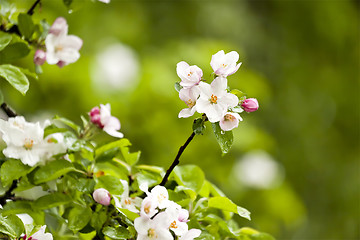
xmin=210 ymin=50 xmax=241 ymax=77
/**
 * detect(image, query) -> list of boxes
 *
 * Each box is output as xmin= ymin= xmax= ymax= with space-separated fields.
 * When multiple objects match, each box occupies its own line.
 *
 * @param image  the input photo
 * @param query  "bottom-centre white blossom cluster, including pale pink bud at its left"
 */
xmin=93 ymin=184 xmax=201 ymax=240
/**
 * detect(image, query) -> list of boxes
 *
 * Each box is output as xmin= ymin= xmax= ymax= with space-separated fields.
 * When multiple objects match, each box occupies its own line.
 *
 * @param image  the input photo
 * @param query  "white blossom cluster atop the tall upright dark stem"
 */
xmin=176 ymin=50 xmax=258 ymax=131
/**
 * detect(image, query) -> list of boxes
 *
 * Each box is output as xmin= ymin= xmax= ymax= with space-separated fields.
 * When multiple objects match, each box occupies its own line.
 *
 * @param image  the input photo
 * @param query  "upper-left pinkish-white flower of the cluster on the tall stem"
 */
xmin=176 ymin=61 xmax=203 ymax=88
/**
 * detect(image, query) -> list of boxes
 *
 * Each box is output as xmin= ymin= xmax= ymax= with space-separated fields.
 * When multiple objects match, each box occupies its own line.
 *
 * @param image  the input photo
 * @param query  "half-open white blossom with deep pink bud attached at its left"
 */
xmin=89 ymin=103 xmax=124 ymax=138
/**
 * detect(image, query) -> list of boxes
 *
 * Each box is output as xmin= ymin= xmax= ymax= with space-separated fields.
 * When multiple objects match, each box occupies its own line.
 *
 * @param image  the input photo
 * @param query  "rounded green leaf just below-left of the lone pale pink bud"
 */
xmin=68 ymin=206 xmax=92 ymax=232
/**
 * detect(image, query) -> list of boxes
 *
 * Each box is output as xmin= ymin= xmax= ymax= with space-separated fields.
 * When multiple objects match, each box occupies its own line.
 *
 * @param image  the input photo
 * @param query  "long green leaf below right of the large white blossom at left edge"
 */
xmin=31 ymin=159 xmax=75 ymax=184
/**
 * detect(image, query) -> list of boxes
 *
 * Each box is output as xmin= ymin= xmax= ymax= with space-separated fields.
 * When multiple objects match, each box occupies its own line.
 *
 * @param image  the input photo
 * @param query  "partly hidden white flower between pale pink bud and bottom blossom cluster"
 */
xmin=113 ymin=180 xmax=143 ymax=213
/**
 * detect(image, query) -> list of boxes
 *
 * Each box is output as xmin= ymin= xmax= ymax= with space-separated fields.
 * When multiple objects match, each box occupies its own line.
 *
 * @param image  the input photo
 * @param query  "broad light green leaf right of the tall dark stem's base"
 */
xmin=174 ymin=165 xmax=205 ymax=193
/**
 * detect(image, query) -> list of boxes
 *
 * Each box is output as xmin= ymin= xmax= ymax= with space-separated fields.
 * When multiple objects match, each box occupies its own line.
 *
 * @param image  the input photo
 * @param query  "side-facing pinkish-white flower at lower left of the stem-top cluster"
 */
xmin=179 ymin=86 xmax=200 ymax=118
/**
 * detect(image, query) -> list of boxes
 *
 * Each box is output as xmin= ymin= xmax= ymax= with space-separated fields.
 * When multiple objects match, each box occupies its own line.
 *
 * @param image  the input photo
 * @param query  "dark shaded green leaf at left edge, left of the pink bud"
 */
xmin=0 ymin=42 xmax=30 ymax=63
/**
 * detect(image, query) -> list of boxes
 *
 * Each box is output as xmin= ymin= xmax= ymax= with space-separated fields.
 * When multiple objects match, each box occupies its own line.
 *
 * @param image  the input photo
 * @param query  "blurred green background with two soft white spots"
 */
xmin=1 ymin=0 xmax=360 ymax=240
